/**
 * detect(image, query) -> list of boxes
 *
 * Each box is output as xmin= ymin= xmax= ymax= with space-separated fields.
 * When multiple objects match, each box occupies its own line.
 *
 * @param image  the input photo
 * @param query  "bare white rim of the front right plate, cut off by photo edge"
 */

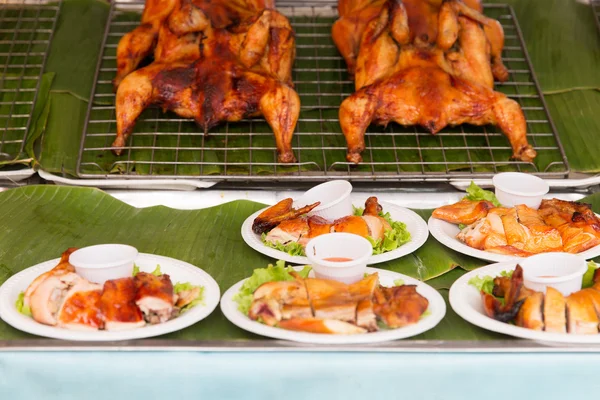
xmin=450 ymin=261 xmax=600 ymax=344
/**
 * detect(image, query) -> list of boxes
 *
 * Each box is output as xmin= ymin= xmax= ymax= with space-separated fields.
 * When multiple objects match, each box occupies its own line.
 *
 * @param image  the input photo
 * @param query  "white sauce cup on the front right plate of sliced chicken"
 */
xmin=519 ymin=253 xmax=587 ymax=296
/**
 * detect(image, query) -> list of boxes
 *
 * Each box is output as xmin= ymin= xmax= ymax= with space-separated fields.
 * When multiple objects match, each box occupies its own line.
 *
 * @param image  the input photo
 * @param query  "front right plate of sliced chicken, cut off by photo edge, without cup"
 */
xmin=450 ymin=262 xmax=600 ymax=343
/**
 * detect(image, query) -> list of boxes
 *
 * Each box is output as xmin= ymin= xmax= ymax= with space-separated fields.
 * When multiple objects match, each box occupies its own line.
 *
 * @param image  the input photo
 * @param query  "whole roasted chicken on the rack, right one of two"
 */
xmin=332 ymin=0 xmax=536 ymax=163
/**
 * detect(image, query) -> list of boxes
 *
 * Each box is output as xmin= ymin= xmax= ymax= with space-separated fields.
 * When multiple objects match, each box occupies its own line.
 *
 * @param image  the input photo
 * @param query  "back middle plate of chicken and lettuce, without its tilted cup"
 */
xmin=242 ymin=197 xmax=429 ymax=264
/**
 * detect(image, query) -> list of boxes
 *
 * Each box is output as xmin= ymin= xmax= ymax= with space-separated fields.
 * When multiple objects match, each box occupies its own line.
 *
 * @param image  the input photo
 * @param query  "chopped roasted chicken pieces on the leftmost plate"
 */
xmin=23 ymin=248 xmax=199 ymax=331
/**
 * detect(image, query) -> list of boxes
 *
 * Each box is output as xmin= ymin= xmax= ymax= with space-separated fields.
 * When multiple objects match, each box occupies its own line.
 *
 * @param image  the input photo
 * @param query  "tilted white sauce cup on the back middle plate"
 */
xmin=294 ymin=180 xmax=352 ymax=221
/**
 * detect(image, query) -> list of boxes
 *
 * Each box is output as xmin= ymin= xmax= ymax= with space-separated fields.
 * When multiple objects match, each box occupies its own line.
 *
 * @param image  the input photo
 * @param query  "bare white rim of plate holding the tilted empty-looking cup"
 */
xmin=242 ymin=202 xmax=429 ymax=265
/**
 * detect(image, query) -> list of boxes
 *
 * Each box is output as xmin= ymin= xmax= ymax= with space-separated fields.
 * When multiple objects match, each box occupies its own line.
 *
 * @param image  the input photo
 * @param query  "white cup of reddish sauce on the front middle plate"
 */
xmin=305 ymin=233 xmax=373 ymax=284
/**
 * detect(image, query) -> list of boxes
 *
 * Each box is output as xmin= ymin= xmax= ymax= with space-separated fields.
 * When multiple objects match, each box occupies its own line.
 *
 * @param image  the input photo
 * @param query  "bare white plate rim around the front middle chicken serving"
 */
xmin=221 ymin=267 xmax=446 ymax=344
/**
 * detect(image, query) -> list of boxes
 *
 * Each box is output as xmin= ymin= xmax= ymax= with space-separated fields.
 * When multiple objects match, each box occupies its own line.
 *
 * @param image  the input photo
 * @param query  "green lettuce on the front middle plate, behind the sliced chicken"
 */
xmin=233 ymin=260 xmax=311 ymax=315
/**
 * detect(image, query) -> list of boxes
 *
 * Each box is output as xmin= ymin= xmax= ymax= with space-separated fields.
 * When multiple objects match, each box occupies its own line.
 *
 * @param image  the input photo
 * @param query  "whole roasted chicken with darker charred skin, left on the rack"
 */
xmin=113 ymin=0 xmax=300 ymax=163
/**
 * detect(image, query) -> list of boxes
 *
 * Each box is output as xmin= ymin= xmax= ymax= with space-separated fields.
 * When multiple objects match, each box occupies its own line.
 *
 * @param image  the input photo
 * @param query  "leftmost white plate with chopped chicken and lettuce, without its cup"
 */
xmin=0 ymin=249 xmax=220 ymax=341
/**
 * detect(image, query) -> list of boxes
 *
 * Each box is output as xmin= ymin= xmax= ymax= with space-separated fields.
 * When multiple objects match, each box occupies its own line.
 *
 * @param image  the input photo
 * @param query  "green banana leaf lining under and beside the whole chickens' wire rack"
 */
xmin=27 ymin=0 xmax=600 ymax=176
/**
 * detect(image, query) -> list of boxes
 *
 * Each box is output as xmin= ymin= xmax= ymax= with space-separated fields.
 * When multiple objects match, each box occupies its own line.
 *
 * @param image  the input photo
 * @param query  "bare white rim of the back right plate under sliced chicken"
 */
xmin=427 ymin=217 xmax=600 ymax=262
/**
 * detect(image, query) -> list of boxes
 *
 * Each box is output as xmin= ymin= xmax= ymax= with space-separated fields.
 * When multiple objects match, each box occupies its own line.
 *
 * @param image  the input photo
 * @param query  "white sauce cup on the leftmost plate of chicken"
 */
xmin=69 ymin=244 xmax=138 ymax=285
